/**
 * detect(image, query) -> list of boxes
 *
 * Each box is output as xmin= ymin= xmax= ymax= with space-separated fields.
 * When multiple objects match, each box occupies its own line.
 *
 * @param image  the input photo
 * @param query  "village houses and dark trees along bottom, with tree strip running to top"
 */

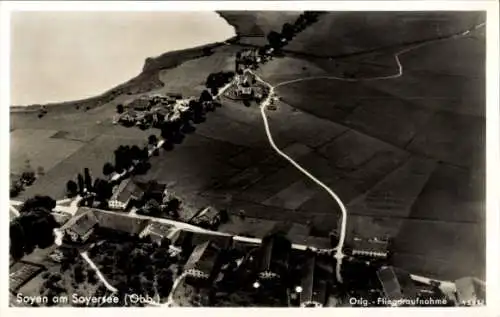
xmin=10 ymin=12 xmax=484 ymax=307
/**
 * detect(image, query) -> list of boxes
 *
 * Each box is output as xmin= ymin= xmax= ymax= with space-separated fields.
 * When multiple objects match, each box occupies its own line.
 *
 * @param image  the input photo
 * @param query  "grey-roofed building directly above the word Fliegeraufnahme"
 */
xmin=377 ymin=266 xmax=418 ymax=306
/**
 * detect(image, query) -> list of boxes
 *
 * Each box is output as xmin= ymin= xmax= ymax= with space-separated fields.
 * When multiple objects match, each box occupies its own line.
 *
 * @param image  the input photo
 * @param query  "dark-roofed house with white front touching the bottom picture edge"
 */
xmin=299 ymin=254 xmax=328 ymax=307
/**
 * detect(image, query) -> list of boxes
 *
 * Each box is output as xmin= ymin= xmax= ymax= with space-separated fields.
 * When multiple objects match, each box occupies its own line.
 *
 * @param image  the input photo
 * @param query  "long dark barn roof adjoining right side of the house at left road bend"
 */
xmin=95 ymin=210 xmax=148 ymax=234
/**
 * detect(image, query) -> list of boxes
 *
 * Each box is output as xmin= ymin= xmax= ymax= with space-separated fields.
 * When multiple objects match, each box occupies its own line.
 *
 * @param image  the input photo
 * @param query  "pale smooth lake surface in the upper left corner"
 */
xmin=10 ymin=11 xmax=234 ymax=105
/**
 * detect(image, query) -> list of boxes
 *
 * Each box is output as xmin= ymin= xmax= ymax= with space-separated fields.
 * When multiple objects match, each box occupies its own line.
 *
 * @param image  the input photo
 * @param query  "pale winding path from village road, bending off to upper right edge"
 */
xmin=247 ymin=23 xmax=486 ymax=283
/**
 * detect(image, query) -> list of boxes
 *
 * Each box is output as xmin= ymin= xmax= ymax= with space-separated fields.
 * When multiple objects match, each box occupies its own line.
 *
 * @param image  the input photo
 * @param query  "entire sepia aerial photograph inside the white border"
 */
xmin=6 ymin=8 xmax=489 ymax=308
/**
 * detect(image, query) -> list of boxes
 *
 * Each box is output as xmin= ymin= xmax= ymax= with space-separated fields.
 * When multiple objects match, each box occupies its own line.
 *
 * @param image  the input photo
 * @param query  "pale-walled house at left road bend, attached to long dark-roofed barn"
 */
xmin=60 ymin=208 xmax=99 ymax=243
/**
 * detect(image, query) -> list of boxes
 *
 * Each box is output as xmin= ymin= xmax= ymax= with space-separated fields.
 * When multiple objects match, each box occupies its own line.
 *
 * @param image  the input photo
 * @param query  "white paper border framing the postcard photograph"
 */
xmin=0 ymin=0 xmax=500 ymax=317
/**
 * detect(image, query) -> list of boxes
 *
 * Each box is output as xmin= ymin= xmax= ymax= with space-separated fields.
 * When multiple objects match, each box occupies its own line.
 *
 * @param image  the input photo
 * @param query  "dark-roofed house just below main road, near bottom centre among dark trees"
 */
xmin=258 ymin=234 xmax=292 ymax=280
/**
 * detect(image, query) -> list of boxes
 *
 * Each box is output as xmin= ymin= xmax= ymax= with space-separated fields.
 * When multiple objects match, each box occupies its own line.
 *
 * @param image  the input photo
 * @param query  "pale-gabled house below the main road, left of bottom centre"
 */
xmin=184 ymin=241 xmax=222 ymax=282
